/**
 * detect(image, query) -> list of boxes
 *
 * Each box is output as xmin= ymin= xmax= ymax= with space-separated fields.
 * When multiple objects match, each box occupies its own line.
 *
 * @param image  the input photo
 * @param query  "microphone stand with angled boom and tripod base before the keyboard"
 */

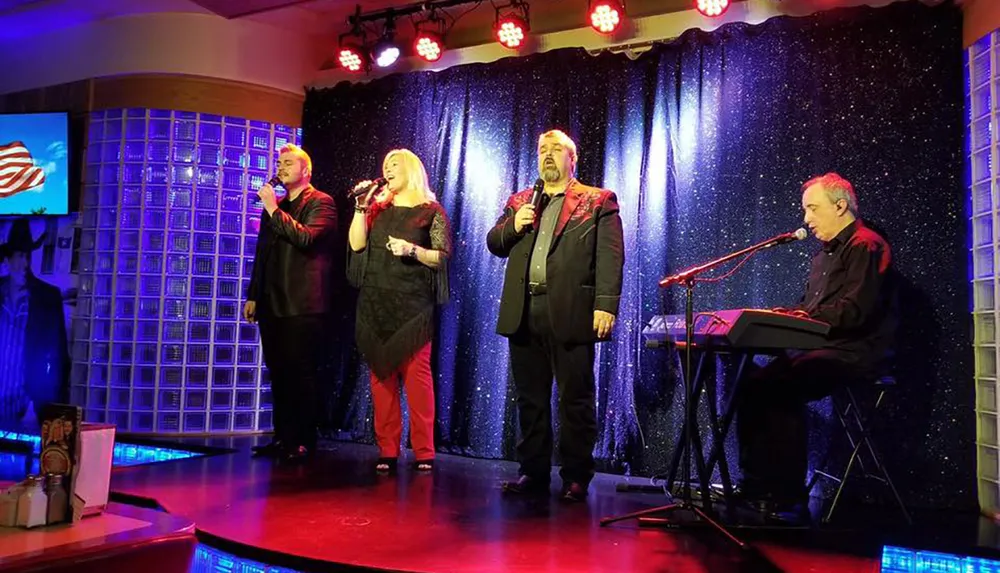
xmin=600 ymin=235 xmax=796 ymax=549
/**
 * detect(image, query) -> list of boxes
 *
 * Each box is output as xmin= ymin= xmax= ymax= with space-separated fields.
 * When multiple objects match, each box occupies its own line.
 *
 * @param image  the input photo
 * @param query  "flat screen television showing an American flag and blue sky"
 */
xmin=0 ymin=113 xmax=70 ymax=216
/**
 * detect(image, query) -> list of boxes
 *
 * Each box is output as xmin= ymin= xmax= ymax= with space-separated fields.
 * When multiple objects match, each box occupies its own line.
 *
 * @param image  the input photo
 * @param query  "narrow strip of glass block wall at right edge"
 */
xmin=965 ymin=32 xmax=1000 ymax=509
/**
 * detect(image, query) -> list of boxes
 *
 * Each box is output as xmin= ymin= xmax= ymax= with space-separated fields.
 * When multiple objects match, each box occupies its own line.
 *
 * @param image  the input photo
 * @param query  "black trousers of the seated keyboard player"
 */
xmin=736 ymin=349 xmax=864 ymax=502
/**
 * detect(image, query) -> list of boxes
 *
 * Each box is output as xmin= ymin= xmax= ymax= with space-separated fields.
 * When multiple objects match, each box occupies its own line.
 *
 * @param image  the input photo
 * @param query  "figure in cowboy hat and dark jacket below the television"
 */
xmin=0 ymin=219 xmax=70 ymax=423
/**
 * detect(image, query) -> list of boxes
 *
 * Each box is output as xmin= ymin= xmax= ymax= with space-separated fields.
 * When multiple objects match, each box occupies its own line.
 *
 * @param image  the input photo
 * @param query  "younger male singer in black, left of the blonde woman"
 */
xmin=243 ymin=144 xmax=337 ymax=461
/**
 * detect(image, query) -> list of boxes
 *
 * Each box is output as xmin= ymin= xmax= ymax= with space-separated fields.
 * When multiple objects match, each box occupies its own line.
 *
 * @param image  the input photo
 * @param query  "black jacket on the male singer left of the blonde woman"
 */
xmin=247 ymin=187 xmax=337 ymax=318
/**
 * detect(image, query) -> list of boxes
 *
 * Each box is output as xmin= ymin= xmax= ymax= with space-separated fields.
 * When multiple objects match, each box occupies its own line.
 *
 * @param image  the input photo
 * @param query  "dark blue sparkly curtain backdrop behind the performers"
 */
xmin=304 ymin=2 xmax=976 ymax=507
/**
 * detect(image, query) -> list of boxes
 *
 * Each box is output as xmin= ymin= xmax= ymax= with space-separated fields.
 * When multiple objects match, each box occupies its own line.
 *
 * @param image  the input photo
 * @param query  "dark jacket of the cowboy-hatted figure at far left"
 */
xmin=0 ymin=275 xmax=70 ymax=407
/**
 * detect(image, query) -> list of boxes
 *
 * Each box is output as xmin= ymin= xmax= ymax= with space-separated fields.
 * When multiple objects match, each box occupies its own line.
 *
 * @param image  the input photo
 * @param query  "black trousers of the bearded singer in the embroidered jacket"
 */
xmin=509 ymin=295 xmax=597 ymax=487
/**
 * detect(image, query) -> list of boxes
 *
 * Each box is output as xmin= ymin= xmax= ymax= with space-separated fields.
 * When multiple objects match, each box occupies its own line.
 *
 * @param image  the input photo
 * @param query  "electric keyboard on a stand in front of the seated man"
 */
xmin=642 ymin=308 xmax=830 ymax=351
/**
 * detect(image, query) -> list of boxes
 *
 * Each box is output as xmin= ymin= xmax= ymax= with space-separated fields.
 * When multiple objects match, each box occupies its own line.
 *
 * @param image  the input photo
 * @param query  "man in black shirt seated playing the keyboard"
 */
xmin=737 ymin=173 xmax=896 ymax=521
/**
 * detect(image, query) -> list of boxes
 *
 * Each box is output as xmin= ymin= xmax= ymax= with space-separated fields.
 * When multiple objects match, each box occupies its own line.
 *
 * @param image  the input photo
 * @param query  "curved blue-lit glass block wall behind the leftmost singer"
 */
xmin=70 ymin=109 xmax=301 ymax=434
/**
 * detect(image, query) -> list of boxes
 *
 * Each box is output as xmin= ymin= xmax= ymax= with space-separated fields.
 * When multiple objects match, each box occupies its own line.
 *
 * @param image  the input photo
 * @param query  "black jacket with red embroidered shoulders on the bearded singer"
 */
xmin=486 ymin=179 xmax=625 ymax=344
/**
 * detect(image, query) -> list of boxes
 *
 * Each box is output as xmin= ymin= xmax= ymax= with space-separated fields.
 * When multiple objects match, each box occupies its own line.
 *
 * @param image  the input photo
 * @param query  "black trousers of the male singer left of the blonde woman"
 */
xmin=260 ymin=315 xmax=329 ymax=450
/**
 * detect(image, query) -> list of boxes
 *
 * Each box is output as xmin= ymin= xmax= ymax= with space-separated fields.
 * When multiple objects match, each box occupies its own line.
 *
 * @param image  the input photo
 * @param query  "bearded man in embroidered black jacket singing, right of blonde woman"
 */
xmin=486 ymin=131 xmax=624 ymax=501
